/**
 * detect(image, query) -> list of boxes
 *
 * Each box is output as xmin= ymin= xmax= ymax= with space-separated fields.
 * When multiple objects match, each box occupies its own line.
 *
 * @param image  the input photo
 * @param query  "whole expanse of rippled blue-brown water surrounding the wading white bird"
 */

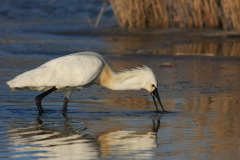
xmin=0 ymin=0 xmax=240 ymax=160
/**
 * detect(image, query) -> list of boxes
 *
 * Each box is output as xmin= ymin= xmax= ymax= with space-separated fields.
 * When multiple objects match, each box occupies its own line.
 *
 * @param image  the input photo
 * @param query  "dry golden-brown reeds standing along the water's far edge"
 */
xmin=109 ymin=0 xmax=240 ymax=30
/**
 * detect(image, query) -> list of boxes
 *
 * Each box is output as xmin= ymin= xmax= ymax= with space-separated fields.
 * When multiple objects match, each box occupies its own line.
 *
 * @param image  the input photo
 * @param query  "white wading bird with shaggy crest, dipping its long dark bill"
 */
xmin=7 ymin=52 xmax=165 ymax=115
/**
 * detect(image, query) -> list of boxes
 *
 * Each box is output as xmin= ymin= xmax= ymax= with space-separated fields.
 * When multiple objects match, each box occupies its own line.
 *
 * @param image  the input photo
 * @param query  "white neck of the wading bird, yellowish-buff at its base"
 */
xmin=99 ymin=65 xmax=142 ymax=90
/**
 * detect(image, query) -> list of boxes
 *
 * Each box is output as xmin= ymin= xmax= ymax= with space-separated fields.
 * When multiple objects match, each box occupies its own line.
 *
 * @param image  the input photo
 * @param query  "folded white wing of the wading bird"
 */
xmin=7 ymin=54 xmax=104 ymax=90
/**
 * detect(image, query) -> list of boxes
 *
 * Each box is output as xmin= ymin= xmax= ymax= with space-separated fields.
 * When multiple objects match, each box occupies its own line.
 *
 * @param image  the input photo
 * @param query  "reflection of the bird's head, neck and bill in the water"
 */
xmin=98 ymin=118 xmax=160 ymax=159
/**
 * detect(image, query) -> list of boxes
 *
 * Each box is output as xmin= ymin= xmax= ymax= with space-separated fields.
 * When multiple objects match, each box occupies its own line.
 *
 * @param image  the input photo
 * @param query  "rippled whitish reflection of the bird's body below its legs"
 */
xmin=7 ymin=116 xmax=99 ymax=160
